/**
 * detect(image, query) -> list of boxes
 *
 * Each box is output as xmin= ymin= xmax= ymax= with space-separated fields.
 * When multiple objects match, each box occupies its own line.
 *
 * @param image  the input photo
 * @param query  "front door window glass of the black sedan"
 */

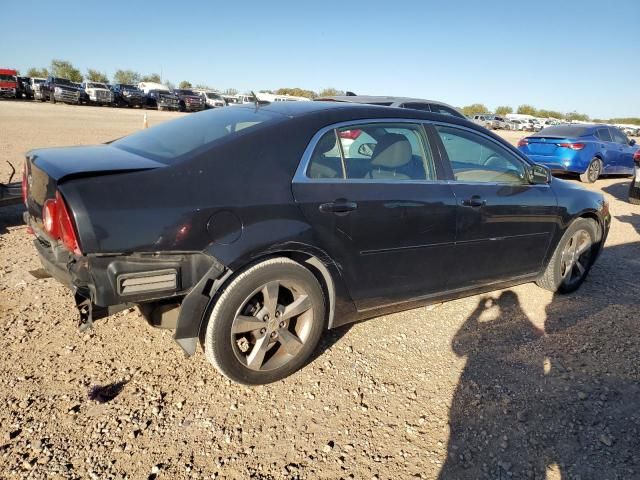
xmin=436 ymin=126 xmax=528 ymax=184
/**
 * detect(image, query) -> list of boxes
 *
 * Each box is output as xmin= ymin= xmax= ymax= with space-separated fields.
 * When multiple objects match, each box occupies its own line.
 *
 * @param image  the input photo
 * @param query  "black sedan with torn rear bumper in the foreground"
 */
xmin=23 ymin=102 xmax=610 ymax=384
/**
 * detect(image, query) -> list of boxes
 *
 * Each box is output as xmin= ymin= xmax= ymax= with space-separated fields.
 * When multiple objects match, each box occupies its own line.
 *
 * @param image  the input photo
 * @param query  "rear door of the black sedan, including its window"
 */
xmin=293 ymin=120 xmax=456 ymax=311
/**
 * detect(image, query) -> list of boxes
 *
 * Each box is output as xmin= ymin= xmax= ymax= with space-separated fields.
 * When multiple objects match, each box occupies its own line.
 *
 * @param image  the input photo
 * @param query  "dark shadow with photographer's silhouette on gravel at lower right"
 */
xmin=439 ymin=243 xmax=640 ymax=480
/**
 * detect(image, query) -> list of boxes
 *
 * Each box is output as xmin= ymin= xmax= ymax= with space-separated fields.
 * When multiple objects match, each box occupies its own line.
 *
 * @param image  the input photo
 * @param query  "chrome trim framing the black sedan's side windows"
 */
xmin=292 ymin=118 xmax=550 ymax=188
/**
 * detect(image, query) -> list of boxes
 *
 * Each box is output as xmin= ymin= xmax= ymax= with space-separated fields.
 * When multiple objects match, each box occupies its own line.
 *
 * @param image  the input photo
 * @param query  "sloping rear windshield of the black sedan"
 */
xmin=111 ymin=107 xmax=286 ymax=164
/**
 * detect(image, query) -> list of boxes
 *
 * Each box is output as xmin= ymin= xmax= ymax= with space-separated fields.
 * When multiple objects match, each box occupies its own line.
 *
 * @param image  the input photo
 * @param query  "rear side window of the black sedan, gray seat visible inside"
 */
xmin=307 ymin=123 xmax=436 ymax=182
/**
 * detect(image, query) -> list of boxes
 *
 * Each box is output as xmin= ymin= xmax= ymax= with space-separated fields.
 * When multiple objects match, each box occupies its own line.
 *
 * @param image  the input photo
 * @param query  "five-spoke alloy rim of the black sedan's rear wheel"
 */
xmin=231 ymin=281 xmax=314 ymax=371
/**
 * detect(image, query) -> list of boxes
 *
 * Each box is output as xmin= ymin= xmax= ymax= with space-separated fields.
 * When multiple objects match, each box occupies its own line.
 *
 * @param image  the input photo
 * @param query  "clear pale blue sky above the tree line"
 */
xmin=5 ymin=0 xmax=640 ymax=118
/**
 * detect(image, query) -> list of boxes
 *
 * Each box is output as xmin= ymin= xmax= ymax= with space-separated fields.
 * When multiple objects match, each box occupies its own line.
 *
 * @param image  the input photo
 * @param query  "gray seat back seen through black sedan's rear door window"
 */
xmin=369 ymin=133 xmax=413 ymax=180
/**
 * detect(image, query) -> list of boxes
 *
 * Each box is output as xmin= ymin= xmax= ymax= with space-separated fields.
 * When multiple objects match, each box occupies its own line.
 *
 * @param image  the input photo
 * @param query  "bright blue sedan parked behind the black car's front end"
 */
xmin=518 ymin=125 xmax=638 ymax=183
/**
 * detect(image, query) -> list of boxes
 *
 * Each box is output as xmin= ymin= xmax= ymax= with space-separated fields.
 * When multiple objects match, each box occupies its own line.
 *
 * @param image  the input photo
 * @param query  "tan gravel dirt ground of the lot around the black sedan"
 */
xmin=0 ymin=102 xmax=640 ymax=480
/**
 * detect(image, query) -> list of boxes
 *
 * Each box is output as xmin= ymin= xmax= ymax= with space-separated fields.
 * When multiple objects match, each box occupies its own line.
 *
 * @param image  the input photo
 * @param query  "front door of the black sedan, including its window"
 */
xmin=434 ymin=124 xmax=559 ymax=289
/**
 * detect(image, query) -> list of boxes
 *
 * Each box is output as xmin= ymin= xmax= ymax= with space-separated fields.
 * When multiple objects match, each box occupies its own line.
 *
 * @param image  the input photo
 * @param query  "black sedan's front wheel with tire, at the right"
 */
xmin=536 ymin=218 xmax=598 ymax=293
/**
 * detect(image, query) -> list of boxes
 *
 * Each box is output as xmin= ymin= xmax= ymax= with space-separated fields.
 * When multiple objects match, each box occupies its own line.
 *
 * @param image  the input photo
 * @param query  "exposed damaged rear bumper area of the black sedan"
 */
xmin=34 ymin=231 xmax=230 ymax=355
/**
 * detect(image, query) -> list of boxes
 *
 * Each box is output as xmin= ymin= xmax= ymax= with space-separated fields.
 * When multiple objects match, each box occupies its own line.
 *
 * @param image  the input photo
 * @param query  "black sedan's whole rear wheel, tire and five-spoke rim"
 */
xmin=204 ymin=258 xmax=325 ymax=385
